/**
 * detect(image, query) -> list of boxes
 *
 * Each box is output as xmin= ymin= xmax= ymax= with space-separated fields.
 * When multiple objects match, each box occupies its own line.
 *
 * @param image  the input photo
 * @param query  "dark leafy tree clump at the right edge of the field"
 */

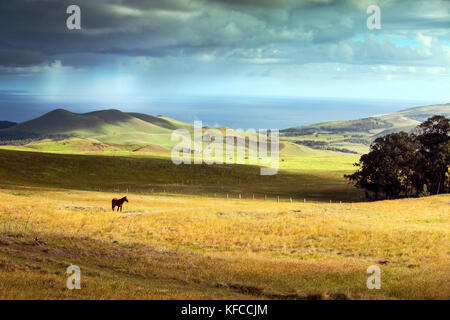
xmin=345 ymin=116 xmax=450 ymax=199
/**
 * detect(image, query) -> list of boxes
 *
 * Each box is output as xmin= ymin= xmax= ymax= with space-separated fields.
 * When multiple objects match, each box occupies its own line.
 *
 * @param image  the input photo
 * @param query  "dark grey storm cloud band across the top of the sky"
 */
xmin=0 ymin=0 xmax=450 ymax=73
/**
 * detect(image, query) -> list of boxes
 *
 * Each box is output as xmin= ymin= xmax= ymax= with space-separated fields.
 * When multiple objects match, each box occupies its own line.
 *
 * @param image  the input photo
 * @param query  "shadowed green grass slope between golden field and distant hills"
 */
xmin=0 ymin=149 xmax=361 ymax=201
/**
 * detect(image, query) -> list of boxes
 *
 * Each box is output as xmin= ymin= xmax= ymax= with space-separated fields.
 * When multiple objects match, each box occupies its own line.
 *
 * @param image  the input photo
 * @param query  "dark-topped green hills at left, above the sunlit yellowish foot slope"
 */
xmin=0 ymin=109 xmax=190 ymax=147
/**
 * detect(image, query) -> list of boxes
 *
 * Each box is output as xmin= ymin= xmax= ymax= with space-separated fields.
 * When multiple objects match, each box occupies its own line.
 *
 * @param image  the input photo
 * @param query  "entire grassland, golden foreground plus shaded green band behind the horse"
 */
xmin=0 ymin=146 xmax=450 ymax=299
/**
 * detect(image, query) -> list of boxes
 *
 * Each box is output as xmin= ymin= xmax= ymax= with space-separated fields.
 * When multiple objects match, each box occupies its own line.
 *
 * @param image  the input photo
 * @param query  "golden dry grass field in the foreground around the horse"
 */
xmin=0 ymin=188 xmax=450 ymax=299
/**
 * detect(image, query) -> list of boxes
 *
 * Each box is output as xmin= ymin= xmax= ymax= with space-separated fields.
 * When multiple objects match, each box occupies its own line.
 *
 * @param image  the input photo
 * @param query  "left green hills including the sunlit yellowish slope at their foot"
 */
xmin=0 ymin=109 xmax=268 ymax=153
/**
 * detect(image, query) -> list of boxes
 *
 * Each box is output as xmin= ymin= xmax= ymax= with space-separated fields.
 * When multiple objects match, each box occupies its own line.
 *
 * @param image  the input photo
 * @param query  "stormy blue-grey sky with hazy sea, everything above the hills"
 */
xmin=0 ymin=0 xmax=450 ymax=126
